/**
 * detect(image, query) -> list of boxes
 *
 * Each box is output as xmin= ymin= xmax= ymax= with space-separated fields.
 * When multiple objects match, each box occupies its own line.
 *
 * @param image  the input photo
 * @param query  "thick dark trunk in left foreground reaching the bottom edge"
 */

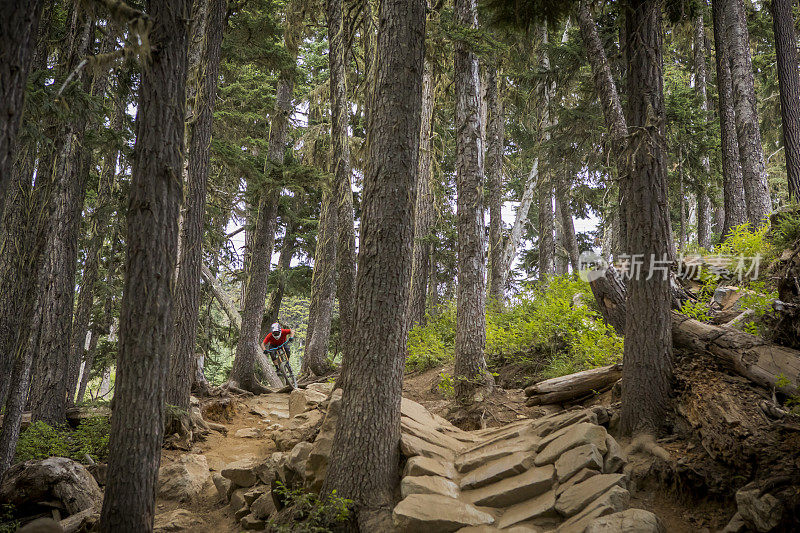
xmin=99 ymin=0 xmax=191 ymax=533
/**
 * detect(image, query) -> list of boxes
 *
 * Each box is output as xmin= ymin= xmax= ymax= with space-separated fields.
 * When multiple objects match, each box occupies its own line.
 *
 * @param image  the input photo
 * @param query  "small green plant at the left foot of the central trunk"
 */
xmin=269 ymin=482 xmax=353 ymax=533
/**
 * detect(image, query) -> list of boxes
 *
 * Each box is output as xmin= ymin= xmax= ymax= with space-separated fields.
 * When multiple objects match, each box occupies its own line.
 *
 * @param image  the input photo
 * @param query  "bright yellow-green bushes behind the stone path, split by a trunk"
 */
xmin=406 ymin=276 xmax=622 ymax=377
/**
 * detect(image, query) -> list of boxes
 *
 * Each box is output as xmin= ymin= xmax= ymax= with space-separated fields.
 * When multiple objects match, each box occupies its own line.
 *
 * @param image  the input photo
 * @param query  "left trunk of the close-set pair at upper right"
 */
xmin=711 ymin=0 xmax=747 ymax=239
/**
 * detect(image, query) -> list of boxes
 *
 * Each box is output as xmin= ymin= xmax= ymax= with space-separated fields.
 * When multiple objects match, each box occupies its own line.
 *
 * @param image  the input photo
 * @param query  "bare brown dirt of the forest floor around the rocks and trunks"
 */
xmin=156 ymin=365 xmax=735 ymax=533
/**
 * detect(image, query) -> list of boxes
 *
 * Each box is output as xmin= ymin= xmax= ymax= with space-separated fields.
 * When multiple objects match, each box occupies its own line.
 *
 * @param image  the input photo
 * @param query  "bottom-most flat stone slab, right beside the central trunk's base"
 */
xmin=392 ymin=494 xmax=494 ymax=533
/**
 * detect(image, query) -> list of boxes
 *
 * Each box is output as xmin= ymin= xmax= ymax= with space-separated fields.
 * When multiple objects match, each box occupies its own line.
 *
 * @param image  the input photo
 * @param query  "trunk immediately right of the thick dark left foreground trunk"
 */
xmin=167 ymin=0 xmax=228 ymax=410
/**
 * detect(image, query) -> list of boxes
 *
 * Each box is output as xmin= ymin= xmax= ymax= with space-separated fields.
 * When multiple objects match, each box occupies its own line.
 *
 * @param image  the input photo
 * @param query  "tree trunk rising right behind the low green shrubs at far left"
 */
xmin=29 ymin=12 xmax=93 ymax=426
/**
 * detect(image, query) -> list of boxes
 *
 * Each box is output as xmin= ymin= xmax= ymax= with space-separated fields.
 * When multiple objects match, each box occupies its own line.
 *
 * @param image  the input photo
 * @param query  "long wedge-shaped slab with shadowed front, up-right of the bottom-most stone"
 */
xmin=461 ymin=465 xmax=555 ymax=508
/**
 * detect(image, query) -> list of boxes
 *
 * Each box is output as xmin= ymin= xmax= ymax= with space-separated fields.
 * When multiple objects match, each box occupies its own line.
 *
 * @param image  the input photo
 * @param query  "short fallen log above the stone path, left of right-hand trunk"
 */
xmin=525 ymin=364 xmax=622 ymax=407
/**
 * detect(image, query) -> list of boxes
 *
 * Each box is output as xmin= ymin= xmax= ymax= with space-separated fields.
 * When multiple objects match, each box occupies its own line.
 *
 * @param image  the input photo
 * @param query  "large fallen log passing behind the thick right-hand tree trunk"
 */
xmin=589 ymin=268 xmax=800 ymax=396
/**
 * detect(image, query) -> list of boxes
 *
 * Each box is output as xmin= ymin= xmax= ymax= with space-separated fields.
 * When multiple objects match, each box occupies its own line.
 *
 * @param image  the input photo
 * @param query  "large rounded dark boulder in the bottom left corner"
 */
xmin=0 ymin=457 xmax=103 ymax=514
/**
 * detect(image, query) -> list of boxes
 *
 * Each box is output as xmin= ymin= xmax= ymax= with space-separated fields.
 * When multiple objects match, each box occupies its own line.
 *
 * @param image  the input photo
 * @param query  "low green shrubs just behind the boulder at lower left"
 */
xmin=14 ymin=417 xmax=111 ymax=462
